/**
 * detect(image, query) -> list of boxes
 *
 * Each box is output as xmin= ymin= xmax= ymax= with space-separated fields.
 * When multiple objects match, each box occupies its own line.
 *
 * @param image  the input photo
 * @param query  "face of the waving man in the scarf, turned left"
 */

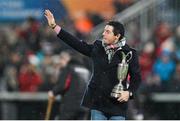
xmin=102 ymin=25 xmax=120 ymax=44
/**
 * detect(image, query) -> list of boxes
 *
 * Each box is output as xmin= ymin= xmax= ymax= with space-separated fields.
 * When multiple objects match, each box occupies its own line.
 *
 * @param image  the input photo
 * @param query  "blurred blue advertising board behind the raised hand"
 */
xmin=0 ymin=0 xmax=66 ymax=22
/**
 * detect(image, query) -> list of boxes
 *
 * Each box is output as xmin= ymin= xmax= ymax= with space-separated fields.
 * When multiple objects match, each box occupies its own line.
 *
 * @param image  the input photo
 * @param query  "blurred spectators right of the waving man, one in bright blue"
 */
xmin=131 ymin=22 xmax=180 ymax=119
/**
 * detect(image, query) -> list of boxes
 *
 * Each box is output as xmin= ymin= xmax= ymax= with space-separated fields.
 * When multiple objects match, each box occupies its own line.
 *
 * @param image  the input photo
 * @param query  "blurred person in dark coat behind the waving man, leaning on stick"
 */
xmin=48 ymin=51 xmax=89 ymax=120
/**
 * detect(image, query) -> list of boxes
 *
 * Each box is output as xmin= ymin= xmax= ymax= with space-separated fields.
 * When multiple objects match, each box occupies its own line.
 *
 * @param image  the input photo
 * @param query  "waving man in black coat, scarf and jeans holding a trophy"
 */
xmin=45 ymin=10 xmax=141 ymax=120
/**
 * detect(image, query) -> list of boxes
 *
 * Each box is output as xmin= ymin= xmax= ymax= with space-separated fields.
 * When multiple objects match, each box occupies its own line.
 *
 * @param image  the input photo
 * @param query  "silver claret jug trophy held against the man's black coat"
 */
xmin=111 ymin=51 xmax=132 ymax=98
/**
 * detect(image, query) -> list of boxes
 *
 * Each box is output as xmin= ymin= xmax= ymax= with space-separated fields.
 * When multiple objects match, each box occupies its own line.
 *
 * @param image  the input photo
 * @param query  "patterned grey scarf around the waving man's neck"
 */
xmin=102 ymin=37 xmax=126 ymax=63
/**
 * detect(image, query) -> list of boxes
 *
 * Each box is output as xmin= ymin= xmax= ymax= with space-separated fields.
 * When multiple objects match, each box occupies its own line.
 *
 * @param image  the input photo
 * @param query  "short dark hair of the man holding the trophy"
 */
xmin=106 ymin=21 xmax=125 ymax=39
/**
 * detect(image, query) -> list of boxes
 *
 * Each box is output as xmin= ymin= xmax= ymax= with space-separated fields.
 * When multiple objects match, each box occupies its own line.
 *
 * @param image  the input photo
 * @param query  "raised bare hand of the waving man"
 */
xmin=44 ymin=10 xmax=56 ymax=29
